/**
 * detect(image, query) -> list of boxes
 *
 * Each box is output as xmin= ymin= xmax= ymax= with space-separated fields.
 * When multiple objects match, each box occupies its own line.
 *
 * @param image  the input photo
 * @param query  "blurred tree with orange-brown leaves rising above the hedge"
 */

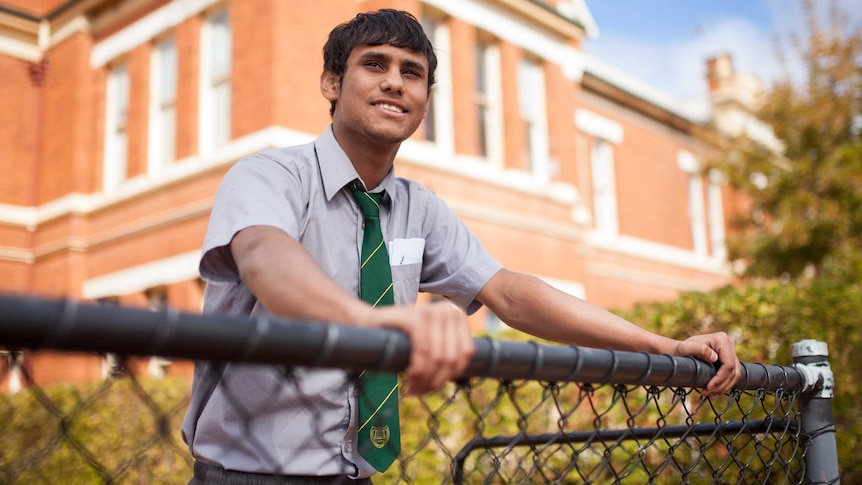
xmin=708 ymin=0 xmax=862 ymax=280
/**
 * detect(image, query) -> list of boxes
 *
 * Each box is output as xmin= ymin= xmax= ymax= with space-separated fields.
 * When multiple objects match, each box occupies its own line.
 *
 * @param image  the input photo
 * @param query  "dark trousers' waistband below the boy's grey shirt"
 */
xmin=189 ymin=461 xmax=374 ymax=485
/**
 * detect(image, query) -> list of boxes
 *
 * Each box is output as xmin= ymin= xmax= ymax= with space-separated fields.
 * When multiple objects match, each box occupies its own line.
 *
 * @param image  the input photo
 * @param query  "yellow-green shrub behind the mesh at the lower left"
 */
xmin=0 ymin=377 xmax=192 ymax=485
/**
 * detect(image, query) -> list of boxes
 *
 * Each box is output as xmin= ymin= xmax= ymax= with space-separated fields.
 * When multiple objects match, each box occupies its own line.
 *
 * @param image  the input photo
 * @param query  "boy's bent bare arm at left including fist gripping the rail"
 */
xmin=231 ymin=226 xmax=475 ymax=393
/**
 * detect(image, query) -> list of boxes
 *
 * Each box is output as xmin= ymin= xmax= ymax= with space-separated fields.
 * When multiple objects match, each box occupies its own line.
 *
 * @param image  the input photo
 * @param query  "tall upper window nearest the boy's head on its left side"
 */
xmin=200 ymin=10 xmax=232 ymax=152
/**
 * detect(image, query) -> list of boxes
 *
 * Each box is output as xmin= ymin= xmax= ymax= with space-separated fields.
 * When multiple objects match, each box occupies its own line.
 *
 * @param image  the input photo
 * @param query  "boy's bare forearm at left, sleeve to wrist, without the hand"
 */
xmin=231 ymin=226 xmax=371 ymax=324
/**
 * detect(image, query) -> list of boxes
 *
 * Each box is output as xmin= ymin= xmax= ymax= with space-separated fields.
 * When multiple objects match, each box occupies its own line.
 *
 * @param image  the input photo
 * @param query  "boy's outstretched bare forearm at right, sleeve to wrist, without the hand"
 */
xmin=479 ymin=270 xmax=679 ymax=353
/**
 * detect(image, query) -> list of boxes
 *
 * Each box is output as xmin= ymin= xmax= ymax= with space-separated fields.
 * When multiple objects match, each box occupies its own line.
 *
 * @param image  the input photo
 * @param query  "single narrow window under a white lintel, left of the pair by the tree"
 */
xmin=590 ymin=138 xmax=619 ymax=235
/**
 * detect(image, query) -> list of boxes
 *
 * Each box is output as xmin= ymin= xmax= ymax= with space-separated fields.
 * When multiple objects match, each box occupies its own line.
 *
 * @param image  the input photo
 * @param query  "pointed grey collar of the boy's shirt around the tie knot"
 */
xmin=314 ymin=125 xmax=395 ymax=201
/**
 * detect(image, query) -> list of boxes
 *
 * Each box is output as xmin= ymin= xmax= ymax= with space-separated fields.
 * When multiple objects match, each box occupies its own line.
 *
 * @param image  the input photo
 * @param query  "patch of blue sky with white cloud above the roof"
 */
xmin=585 ymin=0 xmax=862 ymax=101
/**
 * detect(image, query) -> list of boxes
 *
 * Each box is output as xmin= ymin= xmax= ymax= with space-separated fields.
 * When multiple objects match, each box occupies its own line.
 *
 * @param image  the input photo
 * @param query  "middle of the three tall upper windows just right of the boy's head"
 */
xmin=475 ymin=40 xmax=503 ymax=165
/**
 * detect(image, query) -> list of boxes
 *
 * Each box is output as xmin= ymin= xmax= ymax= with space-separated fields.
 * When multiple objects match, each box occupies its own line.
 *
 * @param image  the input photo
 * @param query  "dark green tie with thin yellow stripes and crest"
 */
xmin=353 ymin=186 xmax=401 ymax=472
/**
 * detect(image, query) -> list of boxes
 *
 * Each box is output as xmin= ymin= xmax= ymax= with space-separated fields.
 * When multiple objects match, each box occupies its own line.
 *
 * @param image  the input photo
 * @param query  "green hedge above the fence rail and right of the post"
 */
xmin=619 ymin=278 xmax=862 ymax=483
